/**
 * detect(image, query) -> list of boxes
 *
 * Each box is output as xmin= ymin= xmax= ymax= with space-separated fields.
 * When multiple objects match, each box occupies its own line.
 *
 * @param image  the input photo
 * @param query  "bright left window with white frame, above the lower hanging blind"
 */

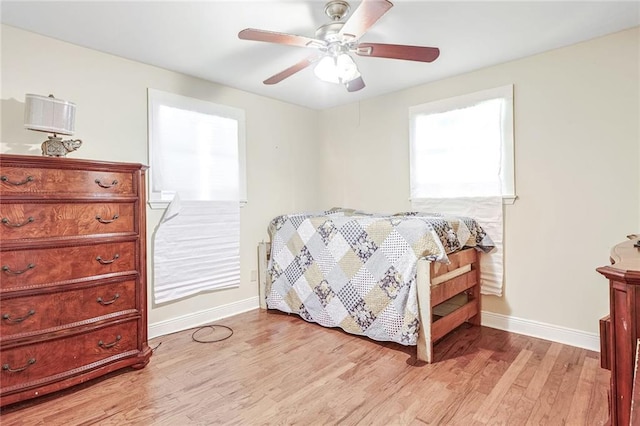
xmin=148 ymin=89 xmax=247 ymax=208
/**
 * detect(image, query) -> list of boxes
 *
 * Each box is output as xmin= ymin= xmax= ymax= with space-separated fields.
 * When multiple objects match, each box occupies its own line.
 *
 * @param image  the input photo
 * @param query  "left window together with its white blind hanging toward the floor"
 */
xmin=149 ymin=89 xmax=246 ymax=303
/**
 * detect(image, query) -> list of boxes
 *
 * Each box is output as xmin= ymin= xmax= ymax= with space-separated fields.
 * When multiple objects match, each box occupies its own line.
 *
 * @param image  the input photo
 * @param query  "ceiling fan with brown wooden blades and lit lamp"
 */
xmin=238 ymin=0 xmax=440 ymax=92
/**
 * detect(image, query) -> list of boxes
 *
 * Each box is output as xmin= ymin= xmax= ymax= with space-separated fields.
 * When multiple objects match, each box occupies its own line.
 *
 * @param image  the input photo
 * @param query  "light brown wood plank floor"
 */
xmin=0 ymin=310 xmax=609 ymax=426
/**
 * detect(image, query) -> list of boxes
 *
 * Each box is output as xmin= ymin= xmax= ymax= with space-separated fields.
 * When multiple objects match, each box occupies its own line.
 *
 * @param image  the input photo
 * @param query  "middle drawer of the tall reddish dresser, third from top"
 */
xmin=0 ymin=241 xmax=137 ymax=293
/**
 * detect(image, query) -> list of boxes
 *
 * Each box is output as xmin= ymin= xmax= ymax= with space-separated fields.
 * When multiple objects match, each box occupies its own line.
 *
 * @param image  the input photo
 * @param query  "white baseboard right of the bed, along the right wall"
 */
xmin=482 ymin=311 xmax=600 ymax=352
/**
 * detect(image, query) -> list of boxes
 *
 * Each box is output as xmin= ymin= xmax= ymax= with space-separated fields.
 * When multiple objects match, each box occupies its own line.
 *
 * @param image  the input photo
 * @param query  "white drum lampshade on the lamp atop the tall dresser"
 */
xmin=24 ymin=94 xmax=76 ymax=135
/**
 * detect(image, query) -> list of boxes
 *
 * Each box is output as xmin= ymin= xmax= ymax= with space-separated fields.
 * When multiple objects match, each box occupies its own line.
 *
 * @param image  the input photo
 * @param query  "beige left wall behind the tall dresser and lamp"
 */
xmin=0 ymin=25 xmax=320 ymax=330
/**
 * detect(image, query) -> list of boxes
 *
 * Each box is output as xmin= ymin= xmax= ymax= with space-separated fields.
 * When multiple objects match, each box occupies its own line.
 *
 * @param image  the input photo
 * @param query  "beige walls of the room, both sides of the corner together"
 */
xmin=0 ymin=26 xmax=640 ymax=340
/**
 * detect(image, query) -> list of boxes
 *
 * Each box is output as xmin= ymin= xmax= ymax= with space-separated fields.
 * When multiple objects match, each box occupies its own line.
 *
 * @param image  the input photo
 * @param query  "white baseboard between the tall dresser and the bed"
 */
xmin=149 ymin=296 xmax=259 ymax=339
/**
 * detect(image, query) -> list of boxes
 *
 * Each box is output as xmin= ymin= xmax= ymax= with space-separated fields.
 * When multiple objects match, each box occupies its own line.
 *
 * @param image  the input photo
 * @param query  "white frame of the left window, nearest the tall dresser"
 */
xmin=147 ymin=88 xmax=247 ymax=209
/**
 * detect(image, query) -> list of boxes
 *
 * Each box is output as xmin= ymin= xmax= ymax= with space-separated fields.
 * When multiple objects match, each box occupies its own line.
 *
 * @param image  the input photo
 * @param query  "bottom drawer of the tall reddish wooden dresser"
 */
xmin=0 ymin=320 xmax=138 ymax=393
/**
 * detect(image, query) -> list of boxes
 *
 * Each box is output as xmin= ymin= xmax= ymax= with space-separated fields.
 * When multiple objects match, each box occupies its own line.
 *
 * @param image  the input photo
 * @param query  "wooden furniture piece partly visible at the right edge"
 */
xmin=597 ymin=236 xmax=640 ymax=426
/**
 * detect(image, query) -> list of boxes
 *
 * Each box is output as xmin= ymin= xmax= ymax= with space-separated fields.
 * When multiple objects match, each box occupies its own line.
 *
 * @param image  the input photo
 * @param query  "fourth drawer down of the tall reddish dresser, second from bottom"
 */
xmin=0 ymin=280 xmax=136 ymax=341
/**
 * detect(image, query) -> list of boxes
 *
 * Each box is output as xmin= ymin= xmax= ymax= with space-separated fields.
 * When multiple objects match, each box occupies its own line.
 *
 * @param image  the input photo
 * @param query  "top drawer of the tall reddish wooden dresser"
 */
xmin=0 ymin=167 xmax=135 ymax=197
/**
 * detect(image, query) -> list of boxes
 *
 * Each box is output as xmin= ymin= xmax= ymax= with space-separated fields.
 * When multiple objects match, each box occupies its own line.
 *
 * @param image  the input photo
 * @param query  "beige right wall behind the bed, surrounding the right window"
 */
xmin=320 ymin=28 xmax=640 ymax=333
